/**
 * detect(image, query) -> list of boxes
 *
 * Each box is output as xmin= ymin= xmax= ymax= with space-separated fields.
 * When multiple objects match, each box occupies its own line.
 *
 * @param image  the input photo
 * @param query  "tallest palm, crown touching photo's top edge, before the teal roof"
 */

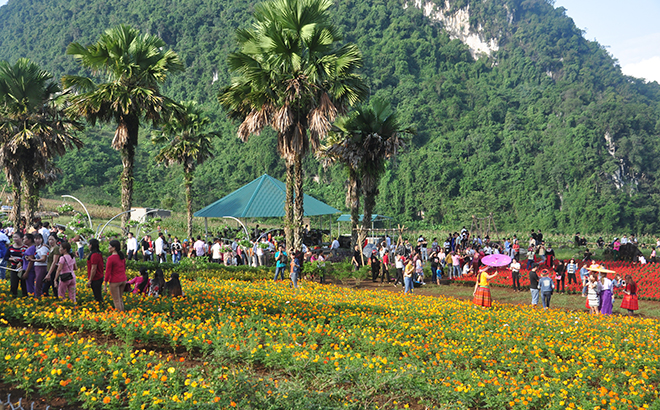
xmin=218 ymin=0 xmax=367 ymax=249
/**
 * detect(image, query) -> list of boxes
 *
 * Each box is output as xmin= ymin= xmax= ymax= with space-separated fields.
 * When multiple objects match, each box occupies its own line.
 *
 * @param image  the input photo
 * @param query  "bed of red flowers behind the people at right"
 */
xmin=456 ymin=261 xmax=660 ymax=300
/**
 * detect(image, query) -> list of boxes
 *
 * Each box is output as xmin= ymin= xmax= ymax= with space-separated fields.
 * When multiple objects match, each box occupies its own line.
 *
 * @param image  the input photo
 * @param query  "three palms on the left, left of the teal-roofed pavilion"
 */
xmin=0 ymin=25 xmax=217 ymax=236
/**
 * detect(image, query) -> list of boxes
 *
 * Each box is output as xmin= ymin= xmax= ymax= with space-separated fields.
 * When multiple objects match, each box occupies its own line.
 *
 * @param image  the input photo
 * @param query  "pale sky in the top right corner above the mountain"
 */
xmin=0 ymin=0 xmax=660 ymax=82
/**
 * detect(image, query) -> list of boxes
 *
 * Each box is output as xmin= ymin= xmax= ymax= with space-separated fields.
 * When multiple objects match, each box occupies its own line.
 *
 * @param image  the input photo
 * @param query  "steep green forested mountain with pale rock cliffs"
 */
xmin=0 ymin=0 xmax=660 ymax=232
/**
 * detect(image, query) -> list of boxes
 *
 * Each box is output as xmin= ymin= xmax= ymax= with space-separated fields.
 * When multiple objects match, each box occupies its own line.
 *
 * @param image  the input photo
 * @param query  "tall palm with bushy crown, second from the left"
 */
xmin=64 ymin=25 xmax=184 ymax=227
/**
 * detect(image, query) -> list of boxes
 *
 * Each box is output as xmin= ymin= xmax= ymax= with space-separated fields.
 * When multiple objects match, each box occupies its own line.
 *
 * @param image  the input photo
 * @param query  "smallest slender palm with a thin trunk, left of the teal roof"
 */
xmin=152 ymin=101 xmax=220 ymax=238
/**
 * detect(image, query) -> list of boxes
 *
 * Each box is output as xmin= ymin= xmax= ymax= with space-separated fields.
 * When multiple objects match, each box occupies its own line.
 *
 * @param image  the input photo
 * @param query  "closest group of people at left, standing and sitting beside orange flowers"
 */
xmin=0 ymin=221 xmax=183 ymax=311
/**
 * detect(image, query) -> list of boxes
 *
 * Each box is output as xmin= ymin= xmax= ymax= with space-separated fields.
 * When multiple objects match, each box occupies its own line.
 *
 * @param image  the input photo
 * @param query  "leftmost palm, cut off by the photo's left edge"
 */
xmin=0 ymin=59 xmax=82 ymax=226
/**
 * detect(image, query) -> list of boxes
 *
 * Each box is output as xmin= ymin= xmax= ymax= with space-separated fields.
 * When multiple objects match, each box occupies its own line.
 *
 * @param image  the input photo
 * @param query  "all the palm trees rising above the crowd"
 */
xmin=0 ymin=0 xmax=412 ymax=248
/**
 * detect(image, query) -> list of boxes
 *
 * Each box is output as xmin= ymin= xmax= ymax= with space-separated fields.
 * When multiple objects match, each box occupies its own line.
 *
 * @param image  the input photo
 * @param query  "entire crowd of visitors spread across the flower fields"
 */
xmin=0 ymin=216 xmax=640 ymax=314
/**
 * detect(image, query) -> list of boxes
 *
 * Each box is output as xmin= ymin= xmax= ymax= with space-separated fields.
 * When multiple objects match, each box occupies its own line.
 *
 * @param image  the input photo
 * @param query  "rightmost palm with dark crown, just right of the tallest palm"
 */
xmin=320 ymin=99 xmax=415 ymax=247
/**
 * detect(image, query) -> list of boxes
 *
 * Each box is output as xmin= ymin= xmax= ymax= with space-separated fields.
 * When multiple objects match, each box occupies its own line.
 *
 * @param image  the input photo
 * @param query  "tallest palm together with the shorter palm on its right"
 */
xmin=218 ymin=0 xmax=410 ymax=249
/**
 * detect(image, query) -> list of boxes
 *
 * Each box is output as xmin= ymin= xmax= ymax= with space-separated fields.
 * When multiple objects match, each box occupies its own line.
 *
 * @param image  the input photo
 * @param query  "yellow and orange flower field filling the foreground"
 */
xmin=0 ymin=279 xmax=660 ymax=409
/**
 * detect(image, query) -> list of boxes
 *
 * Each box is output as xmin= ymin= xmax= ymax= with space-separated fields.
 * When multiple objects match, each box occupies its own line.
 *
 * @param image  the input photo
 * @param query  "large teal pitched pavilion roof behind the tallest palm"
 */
xmin=195 ymin=174 xmax=339 ymax=218
